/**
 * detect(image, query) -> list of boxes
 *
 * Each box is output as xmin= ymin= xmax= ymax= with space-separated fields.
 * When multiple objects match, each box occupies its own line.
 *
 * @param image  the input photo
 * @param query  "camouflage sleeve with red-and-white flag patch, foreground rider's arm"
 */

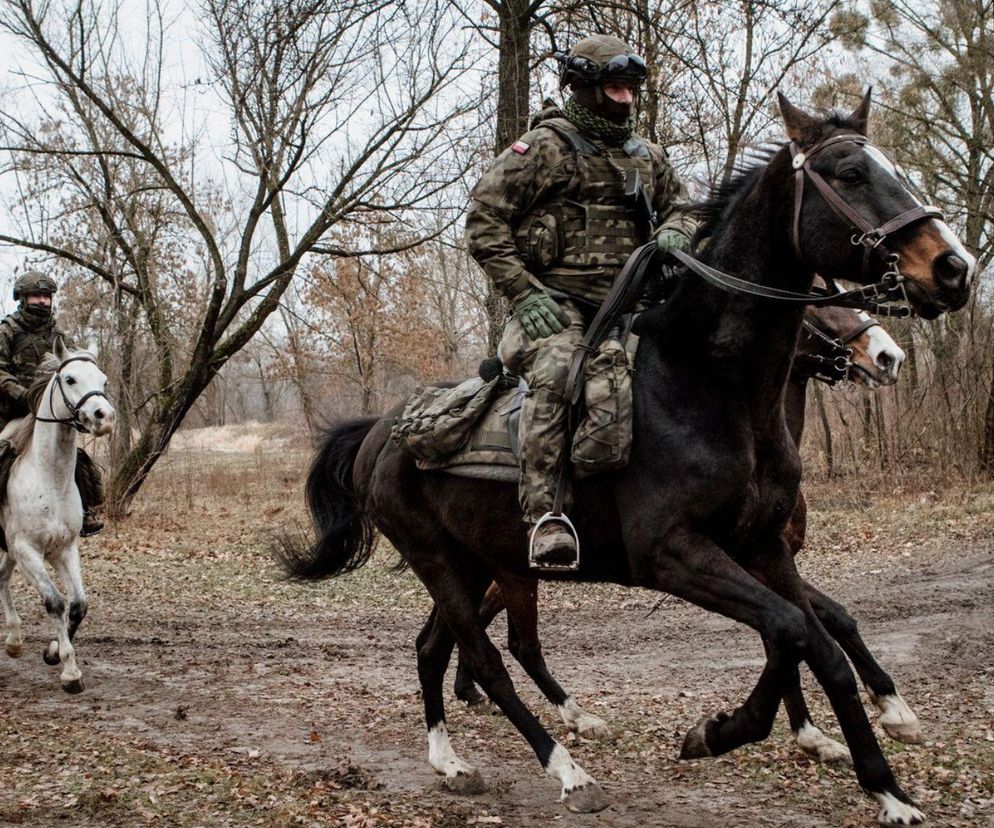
xmin=466 ymin=134 xmax=573 ymax=298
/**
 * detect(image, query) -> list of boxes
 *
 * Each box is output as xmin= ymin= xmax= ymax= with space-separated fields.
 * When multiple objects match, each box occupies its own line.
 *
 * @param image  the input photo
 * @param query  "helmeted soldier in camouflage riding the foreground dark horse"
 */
xmin=466 ymin=35 xmax=694 ymax=568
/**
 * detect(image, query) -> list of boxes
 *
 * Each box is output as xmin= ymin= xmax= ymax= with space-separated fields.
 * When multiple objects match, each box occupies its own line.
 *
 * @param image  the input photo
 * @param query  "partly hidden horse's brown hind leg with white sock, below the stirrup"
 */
xmin=498 ymin=574 xmax=611 ymax=738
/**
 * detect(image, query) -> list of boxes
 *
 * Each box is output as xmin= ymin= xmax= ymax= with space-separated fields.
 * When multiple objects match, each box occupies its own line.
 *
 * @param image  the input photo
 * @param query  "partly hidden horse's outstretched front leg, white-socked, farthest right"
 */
xmin=805 ymin=583 xmax=923 ymax=744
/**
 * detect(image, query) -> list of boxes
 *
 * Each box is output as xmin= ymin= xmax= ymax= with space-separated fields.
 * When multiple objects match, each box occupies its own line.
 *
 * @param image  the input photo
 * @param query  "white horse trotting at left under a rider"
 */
xmin=0 ymin=342 xmax=116 ymax=693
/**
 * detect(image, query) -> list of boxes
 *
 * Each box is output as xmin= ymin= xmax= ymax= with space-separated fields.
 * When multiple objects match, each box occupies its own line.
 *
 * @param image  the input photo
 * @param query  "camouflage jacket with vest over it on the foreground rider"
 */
xmin=466 ymin=108 xmax=695 ymax=304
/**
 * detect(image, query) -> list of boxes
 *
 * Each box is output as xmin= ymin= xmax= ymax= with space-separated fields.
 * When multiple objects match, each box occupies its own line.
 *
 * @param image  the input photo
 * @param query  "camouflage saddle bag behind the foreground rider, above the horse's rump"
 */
xmin=390 ymin=376 xmax=502 ymax=463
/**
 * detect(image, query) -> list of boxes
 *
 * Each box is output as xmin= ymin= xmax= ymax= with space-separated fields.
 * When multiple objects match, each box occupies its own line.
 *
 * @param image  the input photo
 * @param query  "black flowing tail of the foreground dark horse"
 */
xmin=275 ymin=418 xmax=377 ymax=581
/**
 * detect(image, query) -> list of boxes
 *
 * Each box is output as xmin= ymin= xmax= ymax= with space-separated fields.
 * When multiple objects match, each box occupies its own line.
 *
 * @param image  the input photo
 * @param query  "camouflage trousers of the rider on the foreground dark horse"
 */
xmin=497 ymin=301 xmax=586 ymax=523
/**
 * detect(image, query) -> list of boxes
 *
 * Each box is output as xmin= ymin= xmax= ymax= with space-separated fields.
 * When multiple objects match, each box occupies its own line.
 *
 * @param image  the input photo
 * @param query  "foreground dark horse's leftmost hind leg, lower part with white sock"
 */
xmin=417 ymin=607 xmax=486 ymax=794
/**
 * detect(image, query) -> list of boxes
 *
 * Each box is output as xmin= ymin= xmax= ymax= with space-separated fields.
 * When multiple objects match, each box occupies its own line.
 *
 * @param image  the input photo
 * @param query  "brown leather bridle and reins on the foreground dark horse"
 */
xmin=667 ymin=135 xmax=942 ymax=317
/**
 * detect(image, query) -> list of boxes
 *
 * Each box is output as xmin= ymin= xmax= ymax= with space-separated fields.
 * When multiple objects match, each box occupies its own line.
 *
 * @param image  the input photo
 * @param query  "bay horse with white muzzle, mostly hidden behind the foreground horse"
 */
xmin=453 ymin=307 xmax=921 ymax=762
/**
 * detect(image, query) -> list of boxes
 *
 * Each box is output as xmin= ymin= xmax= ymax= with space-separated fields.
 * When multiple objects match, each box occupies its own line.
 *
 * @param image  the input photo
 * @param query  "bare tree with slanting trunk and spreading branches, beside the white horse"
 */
xmin=0 ymin=0 xmax=480 ymax=509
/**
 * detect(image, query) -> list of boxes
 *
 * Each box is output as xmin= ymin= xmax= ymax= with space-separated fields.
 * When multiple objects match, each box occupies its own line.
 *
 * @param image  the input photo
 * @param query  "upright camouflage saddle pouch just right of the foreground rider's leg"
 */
xmin=572 ymin=337 xmax=632 ymax=477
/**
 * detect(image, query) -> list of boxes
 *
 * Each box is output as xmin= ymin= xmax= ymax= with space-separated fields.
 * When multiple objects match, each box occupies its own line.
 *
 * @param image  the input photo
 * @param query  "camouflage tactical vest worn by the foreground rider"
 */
xmin=515 ymin=118 xmax=656 ymax=304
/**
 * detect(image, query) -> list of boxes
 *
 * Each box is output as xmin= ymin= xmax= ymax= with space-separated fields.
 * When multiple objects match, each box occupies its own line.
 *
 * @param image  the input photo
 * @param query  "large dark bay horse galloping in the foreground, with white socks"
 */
xmin=284 ymin=96 xmax=975 ymax=825
